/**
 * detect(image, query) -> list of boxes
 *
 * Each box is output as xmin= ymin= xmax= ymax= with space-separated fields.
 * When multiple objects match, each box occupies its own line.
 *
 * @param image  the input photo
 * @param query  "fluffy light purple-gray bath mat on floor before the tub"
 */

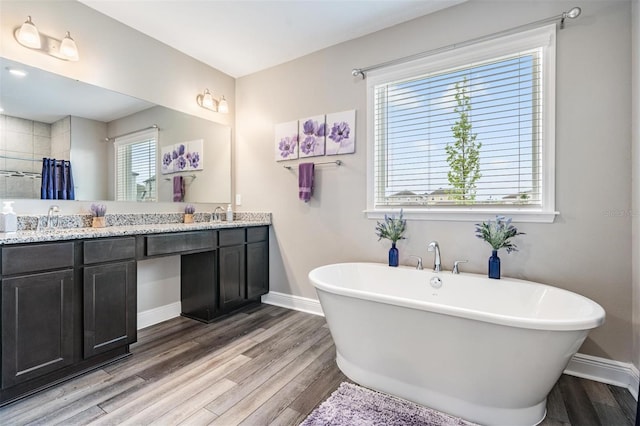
xmin=300 ymin=382 xmax=474 ymax=426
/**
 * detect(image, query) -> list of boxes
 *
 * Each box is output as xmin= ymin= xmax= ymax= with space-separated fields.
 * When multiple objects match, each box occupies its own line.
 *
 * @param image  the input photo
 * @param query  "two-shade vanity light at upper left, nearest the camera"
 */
xmin=13 ymin=16 xmax=80 ymax=62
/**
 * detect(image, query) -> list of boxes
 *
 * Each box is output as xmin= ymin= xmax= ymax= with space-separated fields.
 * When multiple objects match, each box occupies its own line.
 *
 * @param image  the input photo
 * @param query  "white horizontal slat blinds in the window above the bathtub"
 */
xmin=372 ymin=24 xmax=552 ymax=216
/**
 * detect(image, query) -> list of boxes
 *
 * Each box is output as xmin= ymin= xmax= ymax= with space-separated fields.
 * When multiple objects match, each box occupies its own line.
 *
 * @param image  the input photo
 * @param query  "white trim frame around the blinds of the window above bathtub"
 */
xmin=365 ymin=23 xmax=559 ymax=223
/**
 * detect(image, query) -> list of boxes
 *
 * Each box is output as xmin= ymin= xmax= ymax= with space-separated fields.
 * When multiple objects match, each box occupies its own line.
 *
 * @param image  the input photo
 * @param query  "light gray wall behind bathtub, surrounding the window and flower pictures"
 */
xmin=236 ymin=1 xmax=632 ymax=362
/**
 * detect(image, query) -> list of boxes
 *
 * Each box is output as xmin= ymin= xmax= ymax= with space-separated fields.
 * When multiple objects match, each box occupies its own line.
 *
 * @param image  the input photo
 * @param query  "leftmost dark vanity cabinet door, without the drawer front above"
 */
xmin=2 ymin=269 xmax=74 ymax=388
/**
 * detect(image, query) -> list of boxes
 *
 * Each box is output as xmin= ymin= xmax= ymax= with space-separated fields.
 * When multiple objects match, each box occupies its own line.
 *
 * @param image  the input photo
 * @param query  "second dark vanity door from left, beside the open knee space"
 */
xmin=83 ymin=261 xmax=137 ymax=358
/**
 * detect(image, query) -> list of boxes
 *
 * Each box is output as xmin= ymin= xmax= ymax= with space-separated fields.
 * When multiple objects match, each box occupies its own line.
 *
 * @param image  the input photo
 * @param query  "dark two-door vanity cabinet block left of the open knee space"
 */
xmin=0 ymin=237 xmax=137 ymax=405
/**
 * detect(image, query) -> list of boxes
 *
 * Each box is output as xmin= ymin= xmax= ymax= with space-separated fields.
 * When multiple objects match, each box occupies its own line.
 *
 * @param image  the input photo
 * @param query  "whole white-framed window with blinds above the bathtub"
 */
xmin=368 ymin=26 xmax=555 ymax=221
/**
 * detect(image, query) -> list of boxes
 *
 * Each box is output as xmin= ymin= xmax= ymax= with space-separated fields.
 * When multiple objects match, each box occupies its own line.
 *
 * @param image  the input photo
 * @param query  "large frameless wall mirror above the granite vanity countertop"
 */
xmin=0 ymin=58 xmax=231 ymax=204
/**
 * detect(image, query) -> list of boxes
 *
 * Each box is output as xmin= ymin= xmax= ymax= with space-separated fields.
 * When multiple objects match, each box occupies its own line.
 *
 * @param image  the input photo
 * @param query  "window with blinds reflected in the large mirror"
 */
xmin=115 ymin=129 xmax=158 ymax=201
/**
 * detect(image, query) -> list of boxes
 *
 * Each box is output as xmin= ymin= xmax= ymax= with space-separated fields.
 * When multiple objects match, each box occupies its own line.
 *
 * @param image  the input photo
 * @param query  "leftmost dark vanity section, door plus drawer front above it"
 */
xmin=0 ymin=243 xmax=77 ymax=389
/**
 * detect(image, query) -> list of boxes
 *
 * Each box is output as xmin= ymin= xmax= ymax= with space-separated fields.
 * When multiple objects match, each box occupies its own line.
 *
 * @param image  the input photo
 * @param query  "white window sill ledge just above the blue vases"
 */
xmin=364 ymin=208 xmax=560 ymax=223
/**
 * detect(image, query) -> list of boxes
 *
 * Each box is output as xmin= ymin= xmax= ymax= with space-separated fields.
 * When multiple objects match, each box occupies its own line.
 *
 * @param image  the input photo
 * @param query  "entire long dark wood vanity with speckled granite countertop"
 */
xmin=0 ymin=223 xmax=269 ymax=405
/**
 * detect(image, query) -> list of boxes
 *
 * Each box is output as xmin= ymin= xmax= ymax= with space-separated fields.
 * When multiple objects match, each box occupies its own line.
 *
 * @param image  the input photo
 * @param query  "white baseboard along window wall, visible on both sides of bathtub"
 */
xmin=262 ymin=291 xmax=640 ymax=400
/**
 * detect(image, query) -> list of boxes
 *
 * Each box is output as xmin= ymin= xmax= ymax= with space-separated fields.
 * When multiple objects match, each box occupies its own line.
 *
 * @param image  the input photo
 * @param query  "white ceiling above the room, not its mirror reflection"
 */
xmin=79 ymin=0 xmax=466 ymax=78
